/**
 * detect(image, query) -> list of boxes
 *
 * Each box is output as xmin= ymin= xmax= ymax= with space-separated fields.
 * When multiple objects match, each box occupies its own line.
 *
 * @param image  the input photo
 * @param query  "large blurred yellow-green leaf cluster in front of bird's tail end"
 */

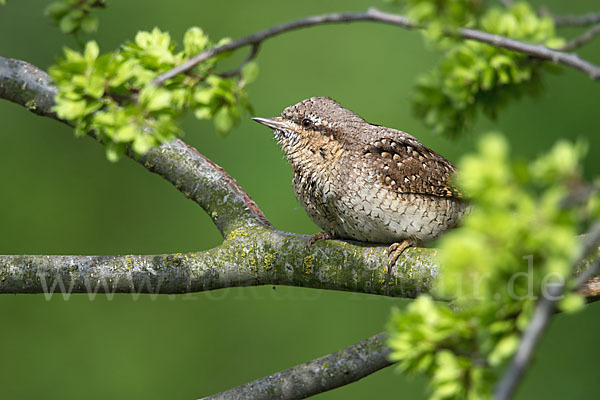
xmin=389 ymin=134 xmax=598 ymax=399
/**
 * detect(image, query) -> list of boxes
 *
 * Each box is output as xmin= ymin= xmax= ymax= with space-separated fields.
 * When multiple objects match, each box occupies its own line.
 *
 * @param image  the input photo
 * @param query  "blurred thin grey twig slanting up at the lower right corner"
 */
xmin=494 ymin=220 xmax=600 ymax=400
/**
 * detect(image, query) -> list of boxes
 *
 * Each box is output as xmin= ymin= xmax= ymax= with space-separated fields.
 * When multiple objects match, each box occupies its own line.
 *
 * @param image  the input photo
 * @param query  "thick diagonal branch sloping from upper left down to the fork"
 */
xmin=0 ymin=57 xmax=269 ymax=236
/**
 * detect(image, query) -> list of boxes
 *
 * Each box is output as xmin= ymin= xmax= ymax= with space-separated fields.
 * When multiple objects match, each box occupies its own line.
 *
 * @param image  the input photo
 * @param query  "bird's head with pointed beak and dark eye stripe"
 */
xmin=253 ymin=97 xmax=365 ymax=164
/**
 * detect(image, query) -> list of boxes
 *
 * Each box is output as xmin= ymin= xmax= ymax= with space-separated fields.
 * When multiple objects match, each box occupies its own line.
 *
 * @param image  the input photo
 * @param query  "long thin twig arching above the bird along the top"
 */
xmin=153 ymin=8 xmax=600 ymax=85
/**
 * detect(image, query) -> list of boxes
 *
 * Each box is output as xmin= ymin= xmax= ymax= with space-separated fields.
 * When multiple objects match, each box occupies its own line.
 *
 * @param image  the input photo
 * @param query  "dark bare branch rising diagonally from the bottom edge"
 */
xmin=203 ymin=333 xmax=393 ymax=400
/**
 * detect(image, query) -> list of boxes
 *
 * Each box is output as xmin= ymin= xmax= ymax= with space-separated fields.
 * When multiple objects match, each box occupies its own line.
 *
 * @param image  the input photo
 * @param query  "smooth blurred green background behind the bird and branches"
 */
xmin=0 ymin=0 xmax=600 ymax=400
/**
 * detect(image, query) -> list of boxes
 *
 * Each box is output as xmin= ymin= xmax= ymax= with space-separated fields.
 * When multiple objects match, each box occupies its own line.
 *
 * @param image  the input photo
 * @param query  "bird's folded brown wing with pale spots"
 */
xmin=363 ymin=131 xmax=462 ymax=198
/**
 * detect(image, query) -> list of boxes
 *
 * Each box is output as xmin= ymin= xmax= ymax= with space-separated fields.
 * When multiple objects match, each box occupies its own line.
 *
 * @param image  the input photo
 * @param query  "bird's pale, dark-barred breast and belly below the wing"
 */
xmin=293 ymin=155 xmax=465 ymax=243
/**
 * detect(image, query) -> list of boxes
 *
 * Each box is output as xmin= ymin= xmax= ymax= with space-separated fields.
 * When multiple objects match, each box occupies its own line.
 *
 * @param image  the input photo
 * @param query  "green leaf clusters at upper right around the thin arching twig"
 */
xmin=403 ymin=0 xmax=564 ymax=136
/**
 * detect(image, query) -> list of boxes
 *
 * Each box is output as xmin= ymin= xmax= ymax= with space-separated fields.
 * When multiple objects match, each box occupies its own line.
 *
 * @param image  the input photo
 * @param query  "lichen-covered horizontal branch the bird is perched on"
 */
xmin=0 ymin=225 xmax=438 ymax=298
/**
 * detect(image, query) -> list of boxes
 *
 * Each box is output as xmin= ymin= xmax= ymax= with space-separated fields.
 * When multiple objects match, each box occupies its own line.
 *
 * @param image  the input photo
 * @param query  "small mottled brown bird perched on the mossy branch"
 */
xmin=253 ymin=97 xmax=467 ymax=274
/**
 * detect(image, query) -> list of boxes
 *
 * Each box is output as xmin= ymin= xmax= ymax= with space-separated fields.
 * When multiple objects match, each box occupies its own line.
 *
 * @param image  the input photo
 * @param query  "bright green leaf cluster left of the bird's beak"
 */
xmin=50 ymin=27 xmax=257 ymax=161
